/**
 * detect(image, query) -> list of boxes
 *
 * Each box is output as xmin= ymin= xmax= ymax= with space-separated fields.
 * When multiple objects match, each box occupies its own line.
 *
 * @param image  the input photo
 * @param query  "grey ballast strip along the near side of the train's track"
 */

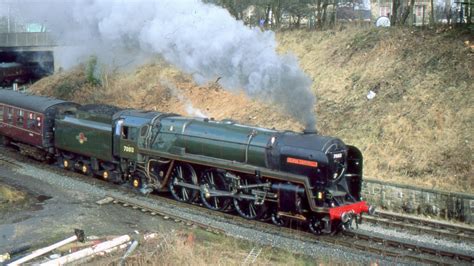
xmin=8 ymin=159 xmax=400 ymax=264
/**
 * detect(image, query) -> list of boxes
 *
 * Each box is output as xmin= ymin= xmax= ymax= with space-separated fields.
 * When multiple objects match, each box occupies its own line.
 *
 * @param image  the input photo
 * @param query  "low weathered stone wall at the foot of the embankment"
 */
xmin=362 ymin=179 xmax=474 ymax=224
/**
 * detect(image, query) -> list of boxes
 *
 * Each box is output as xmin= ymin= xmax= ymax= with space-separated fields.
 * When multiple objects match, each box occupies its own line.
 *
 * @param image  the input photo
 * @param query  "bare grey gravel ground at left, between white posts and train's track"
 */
xmin=0 ymin=163 xmax=182 ymax=254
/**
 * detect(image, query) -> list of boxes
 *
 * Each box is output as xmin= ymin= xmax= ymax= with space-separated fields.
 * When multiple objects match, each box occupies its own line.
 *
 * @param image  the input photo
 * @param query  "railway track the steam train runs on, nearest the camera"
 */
xmin=0 ymin=150 xmax=474 ymax=264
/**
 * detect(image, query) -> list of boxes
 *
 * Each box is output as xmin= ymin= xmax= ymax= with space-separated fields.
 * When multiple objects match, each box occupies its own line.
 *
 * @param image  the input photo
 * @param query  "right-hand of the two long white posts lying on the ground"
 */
xmin=40 ymin=235 xmax=130 ymax=266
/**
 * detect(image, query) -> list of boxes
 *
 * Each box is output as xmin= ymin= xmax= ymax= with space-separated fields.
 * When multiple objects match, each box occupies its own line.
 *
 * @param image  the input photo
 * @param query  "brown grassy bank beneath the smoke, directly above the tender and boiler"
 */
xmin=30 ymin=59 xmax=302 ymax=130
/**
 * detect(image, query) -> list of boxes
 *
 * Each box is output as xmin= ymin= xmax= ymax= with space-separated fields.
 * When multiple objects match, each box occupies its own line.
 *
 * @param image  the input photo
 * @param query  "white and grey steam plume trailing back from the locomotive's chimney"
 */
xmin=0 ymin=0 xmax=316 ymax=129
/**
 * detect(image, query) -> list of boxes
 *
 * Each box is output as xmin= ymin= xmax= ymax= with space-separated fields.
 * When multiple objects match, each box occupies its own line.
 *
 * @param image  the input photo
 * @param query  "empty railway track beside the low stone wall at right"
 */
xmin=363 ymin=211 xmax=474 ymax=242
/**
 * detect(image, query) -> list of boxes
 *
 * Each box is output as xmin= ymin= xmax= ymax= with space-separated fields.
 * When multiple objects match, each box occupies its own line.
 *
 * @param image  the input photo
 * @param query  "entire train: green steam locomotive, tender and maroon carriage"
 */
xmin=0 ymin=90 xmax=374 ymax=234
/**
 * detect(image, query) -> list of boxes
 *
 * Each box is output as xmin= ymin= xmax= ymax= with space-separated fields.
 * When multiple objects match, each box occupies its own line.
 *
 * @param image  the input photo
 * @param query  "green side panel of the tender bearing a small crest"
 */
xmin=55 ymin=116 xmax=114 ymax=162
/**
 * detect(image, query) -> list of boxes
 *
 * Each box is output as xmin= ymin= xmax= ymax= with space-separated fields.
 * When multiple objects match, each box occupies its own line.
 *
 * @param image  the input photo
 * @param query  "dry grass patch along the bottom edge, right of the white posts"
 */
xmin=92 ymin=230 xmax=326 ymax=266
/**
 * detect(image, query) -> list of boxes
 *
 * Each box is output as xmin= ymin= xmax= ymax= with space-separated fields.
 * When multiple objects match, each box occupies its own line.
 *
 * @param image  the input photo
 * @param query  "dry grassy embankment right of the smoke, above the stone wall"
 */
xmin=279 ymin=28 xmax=474 ymax=192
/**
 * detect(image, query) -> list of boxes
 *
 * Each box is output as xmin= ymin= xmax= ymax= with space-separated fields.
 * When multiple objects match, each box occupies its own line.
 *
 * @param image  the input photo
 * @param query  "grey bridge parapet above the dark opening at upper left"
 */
xmin=0 ymin=32 xmax=56 ymax=47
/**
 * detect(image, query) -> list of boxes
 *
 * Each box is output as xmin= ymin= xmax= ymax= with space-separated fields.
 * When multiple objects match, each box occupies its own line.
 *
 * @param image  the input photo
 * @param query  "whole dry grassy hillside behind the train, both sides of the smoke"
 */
xmin=31 ymin=28 xmax=474 ymax=192
